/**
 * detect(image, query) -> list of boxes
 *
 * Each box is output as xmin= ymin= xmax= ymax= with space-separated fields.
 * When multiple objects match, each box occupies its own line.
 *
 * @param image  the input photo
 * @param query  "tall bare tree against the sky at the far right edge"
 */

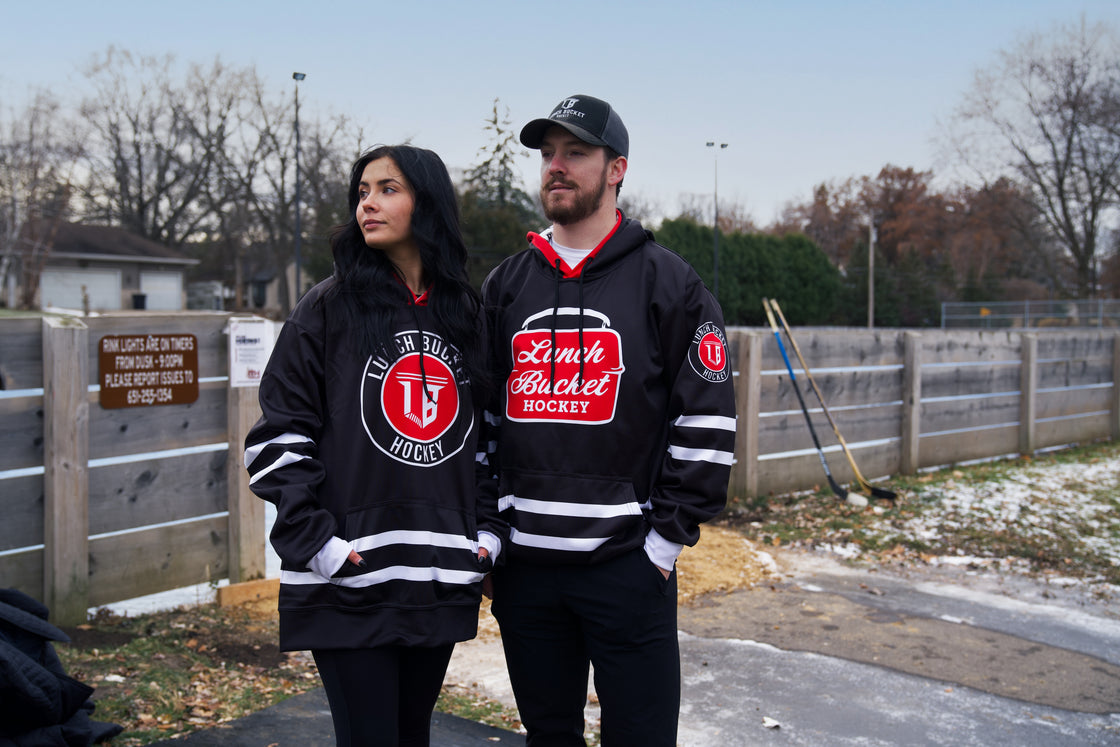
xmin=950 ymin=21 xmax=1120 ymax=298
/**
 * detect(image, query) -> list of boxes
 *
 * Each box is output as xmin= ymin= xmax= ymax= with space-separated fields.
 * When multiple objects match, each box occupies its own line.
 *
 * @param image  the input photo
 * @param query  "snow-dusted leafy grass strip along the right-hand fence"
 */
xmin=720 ymin=441 xmax=1120 ymax=585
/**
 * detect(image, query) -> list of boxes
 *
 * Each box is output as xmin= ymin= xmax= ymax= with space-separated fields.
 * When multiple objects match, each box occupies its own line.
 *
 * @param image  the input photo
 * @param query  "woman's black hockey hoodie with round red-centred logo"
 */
xmin=245 ymin=280 xmax=504 ymax=651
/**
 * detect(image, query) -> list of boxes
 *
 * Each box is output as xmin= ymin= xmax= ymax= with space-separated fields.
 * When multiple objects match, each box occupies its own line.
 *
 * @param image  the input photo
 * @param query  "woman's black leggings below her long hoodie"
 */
xmin=311 ymin=643 xmax=455 ymax=747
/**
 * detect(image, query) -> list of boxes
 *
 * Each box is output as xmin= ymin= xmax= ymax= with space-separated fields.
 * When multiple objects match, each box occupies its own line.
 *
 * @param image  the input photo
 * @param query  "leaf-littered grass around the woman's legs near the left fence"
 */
xmin=55 ymin=604 xmax=520 ymax=747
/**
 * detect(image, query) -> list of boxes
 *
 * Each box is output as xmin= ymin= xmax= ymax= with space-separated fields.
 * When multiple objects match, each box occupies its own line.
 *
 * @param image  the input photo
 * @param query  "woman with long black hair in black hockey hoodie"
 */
xmin=245 ymin=146 xmax=505 ymax=747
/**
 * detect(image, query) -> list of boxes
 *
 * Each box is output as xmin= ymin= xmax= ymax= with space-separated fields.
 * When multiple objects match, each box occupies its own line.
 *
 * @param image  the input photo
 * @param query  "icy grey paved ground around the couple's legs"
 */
xmin=155 ymin=553 xmax=1120 ymax=747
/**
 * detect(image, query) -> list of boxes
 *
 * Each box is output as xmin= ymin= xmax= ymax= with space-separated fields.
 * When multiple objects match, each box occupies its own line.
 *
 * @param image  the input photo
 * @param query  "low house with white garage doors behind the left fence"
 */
xmin=8 ymin=223 xmax=198 ymax=311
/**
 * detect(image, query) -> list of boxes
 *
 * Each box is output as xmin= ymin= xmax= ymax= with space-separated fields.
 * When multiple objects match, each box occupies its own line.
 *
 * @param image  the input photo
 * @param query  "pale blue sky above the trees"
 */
xmin=0 ymin=0 xmax=1120 ymax=225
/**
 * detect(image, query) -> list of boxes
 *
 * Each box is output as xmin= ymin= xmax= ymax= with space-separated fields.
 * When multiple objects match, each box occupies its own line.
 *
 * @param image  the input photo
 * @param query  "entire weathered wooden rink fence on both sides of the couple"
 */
xmin=0 ymin=312 xmax=1120 ymax=623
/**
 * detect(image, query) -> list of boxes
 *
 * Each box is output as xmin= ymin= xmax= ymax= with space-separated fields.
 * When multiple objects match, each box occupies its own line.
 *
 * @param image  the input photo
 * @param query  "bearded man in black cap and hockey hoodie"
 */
xmin=484 ymin=95 xmax=735 ymax=747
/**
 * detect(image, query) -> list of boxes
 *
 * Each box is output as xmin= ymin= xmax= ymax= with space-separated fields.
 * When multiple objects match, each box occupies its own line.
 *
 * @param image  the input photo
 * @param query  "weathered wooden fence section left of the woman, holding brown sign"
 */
xmin=0 ymin=312 xmax=265 ymax=623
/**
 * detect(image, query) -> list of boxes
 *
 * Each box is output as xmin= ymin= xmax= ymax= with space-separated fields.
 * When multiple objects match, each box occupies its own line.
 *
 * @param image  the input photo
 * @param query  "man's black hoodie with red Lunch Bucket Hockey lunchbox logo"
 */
xmin=483 ymin=213 xmax=736 ymax=563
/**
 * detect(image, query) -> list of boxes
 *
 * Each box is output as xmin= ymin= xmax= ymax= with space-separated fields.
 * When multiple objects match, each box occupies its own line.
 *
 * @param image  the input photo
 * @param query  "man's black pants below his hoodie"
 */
xmin=492 ymin=548 xmax=681 ymax=747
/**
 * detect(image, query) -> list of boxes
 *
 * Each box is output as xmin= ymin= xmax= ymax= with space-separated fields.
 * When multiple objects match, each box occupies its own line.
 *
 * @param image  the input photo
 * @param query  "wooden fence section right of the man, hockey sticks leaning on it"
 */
xmin=728 ymin=327 xmax=1120 ymax=497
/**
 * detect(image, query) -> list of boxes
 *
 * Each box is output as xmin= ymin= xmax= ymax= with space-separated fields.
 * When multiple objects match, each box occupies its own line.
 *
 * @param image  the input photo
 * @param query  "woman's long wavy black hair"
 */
xmin=324 ymin=146 xmax=488 ymax=390
